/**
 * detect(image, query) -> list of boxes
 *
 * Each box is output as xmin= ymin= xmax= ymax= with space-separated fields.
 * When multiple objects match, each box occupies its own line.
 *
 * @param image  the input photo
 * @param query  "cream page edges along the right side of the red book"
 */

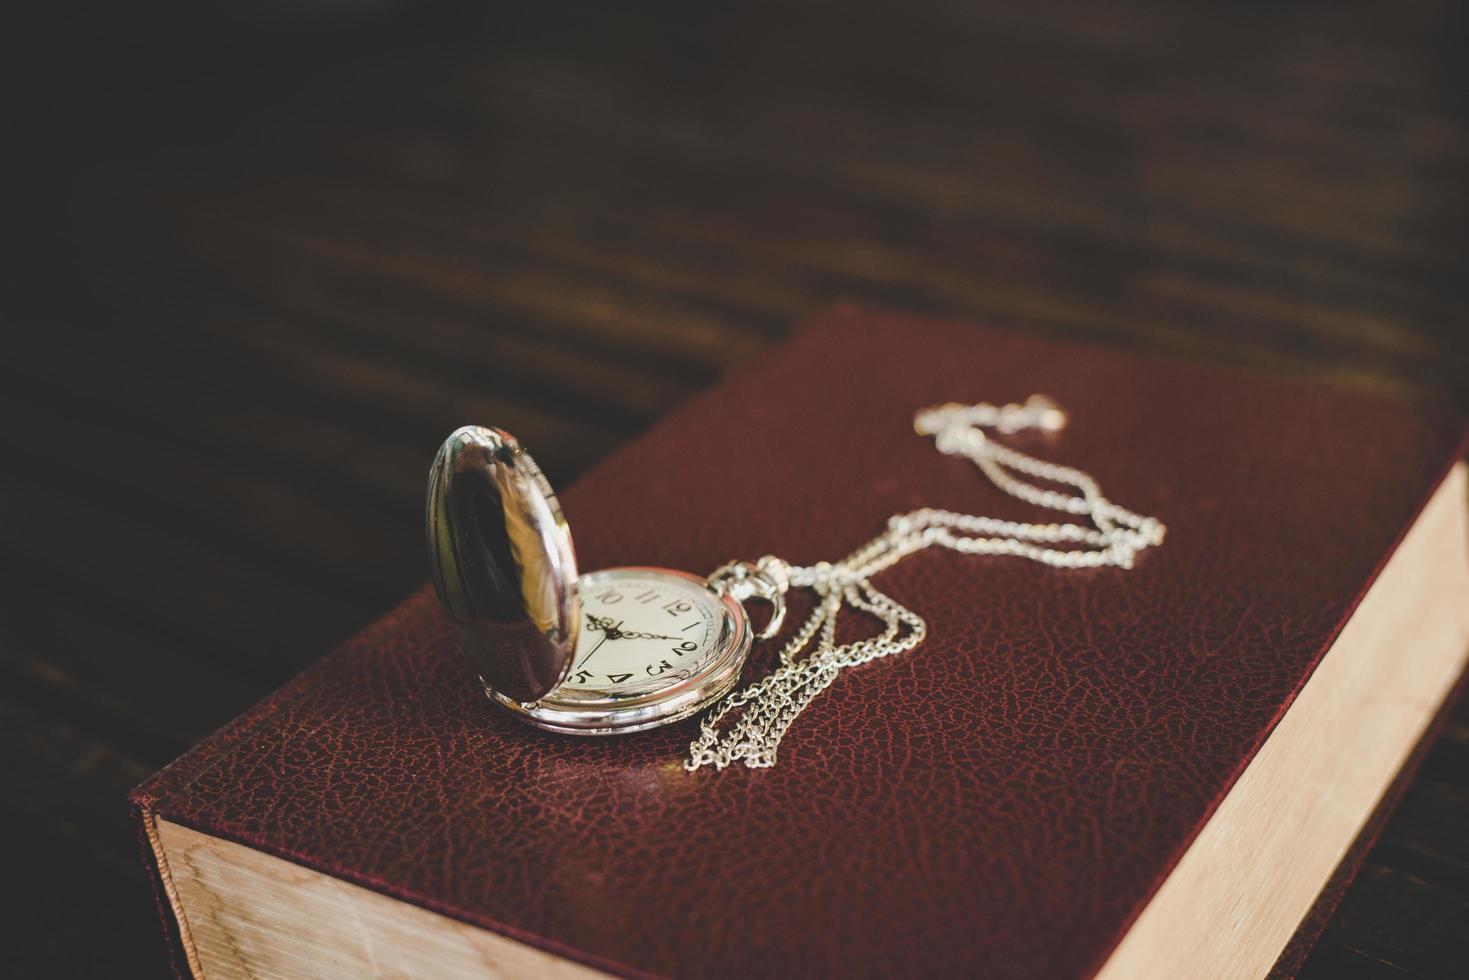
xmin=1096 ymin=461 xmax=1469 ymax=980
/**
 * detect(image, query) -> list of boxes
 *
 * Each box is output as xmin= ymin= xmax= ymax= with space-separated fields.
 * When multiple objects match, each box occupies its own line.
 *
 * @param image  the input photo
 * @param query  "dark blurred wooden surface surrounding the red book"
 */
xmin=0 ymin=0 xmax=1469 ymax=977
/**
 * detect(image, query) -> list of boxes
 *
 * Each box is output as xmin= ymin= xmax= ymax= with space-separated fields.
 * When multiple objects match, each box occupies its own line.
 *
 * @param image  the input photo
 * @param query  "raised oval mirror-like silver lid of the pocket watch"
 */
xmin=425 ymin=426 xmax=580 ymax=702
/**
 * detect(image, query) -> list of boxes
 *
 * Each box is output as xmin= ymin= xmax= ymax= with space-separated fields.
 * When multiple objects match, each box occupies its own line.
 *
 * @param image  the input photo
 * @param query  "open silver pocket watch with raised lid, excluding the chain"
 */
xmin=425 ymin=426 xmax=784 ymax=735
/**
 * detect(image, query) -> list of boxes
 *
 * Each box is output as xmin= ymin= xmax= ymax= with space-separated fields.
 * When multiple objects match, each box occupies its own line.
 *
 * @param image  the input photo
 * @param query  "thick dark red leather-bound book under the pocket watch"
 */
xmin=134 ymin=309 xmax=1469 ymax=977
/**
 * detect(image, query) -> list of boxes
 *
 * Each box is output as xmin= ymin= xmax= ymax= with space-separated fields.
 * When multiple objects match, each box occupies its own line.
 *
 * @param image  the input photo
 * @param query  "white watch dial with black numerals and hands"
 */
xmin=561 ymin=569 xmax=726 ymax=696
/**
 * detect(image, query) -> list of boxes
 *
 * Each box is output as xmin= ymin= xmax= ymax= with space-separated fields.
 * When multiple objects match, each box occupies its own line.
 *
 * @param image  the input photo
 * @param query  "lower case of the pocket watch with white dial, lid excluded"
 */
xmin=489 ymin=569 xmax=751 ymax=735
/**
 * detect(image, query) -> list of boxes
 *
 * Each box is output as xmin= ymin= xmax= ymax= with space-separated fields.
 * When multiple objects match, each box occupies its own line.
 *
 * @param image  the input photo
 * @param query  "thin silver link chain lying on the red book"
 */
xmin=685 ymin=395 xmax=1165 ymax=771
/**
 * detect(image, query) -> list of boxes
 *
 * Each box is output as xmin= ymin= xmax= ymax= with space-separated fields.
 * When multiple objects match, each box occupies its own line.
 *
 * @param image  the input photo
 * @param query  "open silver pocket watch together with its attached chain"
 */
xmin=426 ymin=395 xmax=1163 ymax=770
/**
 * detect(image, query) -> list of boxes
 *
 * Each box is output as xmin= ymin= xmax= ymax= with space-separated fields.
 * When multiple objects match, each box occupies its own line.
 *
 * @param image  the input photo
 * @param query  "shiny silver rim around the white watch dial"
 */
xmin=485 ymin=566 xmax=754 ymax=735
